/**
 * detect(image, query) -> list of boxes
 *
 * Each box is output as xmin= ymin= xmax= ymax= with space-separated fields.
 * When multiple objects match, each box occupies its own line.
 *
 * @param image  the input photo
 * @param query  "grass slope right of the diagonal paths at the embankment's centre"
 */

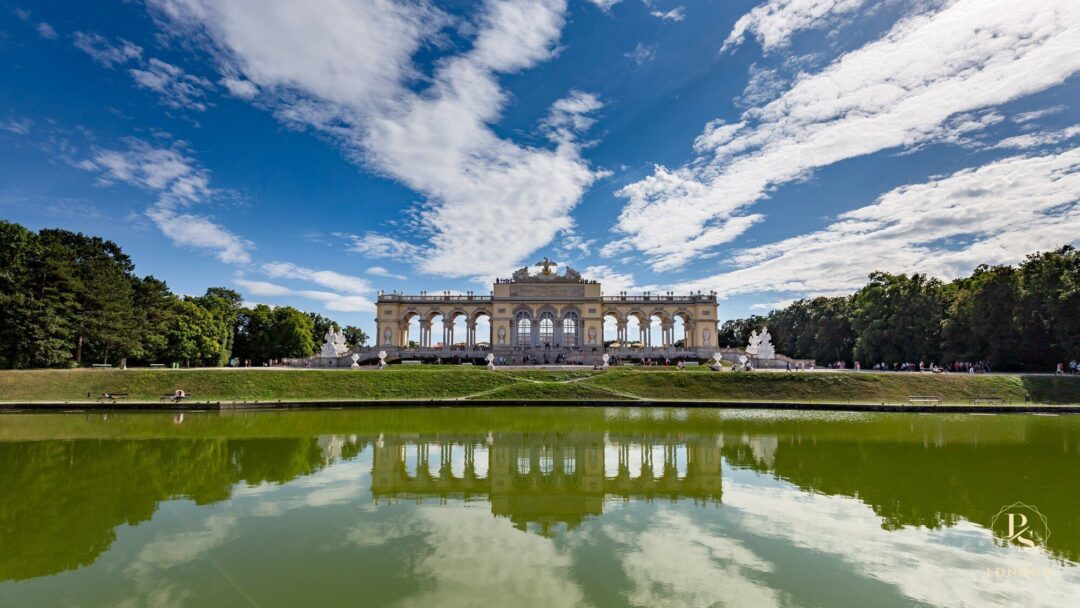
xmin=582 ymin=369 xmax=1080 ymax=404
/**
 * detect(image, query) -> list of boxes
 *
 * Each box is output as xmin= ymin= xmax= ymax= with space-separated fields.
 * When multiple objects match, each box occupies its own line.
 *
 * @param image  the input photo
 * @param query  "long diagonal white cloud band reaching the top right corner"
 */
xmin=617 ymin=0 xmax=1080 ymax=270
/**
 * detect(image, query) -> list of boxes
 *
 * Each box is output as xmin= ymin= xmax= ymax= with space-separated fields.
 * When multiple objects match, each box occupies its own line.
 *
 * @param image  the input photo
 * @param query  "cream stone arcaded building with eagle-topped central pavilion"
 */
xmin=375 ymin=258 xmax=717 ymax=362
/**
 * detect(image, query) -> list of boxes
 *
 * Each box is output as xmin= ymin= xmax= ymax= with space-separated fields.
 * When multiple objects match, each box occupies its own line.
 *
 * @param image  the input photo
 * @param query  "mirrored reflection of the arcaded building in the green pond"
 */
xmin=372 ymin=432 xmax=723 ymax=536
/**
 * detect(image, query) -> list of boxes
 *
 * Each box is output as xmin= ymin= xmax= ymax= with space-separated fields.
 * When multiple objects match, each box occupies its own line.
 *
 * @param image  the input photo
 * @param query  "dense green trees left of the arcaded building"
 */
xmin=0 ymin=220 xmax=367 ymax=369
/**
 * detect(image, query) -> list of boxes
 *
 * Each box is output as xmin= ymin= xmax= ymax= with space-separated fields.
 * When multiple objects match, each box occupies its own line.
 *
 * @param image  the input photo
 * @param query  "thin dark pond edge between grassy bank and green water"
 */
xmin=0 ymin=398 xmax=1080 ymax=414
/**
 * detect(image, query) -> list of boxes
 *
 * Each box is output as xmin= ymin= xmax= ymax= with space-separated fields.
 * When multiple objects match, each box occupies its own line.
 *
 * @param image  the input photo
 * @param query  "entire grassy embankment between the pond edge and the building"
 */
xmin=0 ymin=366 xmax=1080 ymax=404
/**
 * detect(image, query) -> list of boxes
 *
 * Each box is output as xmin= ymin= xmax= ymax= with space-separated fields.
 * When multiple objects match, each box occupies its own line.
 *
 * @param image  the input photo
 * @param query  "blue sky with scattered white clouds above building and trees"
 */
xmin=0 ymin=0 xmax=1080 ymax=336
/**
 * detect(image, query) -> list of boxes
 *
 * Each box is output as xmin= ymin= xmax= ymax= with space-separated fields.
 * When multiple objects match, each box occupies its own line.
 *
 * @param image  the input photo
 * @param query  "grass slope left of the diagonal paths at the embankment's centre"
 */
xmin=0 ymin=367 xmax=521 ymax=402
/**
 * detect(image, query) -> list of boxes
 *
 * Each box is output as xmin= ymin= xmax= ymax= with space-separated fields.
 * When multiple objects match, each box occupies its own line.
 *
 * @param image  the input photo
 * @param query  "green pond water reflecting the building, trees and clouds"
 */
xmin=0 ymin=407 xmax=1080 ymax=608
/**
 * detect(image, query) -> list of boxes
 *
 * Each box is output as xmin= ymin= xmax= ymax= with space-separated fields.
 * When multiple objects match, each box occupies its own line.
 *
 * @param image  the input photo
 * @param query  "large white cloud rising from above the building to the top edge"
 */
xmin=151 ymin=0 xmax=598 ymax=276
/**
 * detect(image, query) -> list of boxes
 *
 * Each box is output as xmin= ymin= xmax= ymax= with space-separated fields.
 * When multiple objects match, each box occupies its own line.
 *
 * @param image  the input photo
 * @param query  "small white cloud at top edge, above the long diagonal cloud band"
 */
xmin=721 ymin=0 xmax=864 ymax=52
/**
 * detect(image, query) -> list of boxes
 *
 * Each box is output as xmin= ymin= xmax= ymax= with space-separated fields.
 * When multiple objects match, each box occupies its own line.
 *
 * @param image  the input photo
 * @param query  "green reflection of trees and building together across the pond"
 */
xmin=0 ymin=407 xmax=1080 ymax=581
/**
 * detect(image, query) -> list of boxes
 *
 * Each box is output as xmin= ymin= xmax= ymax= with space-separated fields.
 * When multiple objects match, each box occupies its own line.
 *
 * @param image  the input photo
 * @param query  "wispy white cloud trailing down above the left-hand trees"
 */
xmin=78 ymin=139 xmax=254 ymax=264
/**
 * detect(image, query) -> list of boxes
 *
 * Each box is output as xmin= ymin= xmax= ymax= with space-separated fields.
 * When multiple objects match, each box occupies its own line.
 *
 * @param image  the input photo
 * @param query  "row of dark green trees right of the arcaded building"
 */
xmin=719 ymin=246 xmax=1080 ymax=371
